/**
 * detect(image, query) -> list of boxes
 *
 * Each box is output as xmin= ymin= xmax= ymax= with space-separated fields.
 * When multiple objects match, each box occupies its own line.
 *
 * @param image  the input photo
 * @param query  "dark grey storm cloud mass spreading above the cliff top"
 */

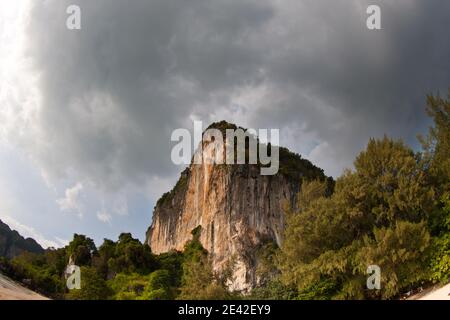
xmin=19 ymin=0 xmax=450 ymax=188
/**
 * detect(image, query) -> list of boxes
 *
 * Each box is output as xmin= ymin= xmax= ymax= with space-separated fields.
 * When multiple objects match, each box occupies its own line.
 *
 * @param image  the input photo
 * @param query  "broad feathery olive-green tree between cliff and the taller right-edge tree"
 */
xmin=277 ymin=137 xmax=434 ymax=299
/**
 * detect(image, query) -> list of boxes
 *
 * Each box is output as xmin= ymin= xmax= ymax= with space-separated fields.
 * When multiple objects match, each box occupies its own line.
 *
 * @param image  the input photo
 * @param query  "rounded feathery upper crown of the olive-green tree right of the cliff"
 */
xmin=350 ymin=137 xmax=434 ymax=227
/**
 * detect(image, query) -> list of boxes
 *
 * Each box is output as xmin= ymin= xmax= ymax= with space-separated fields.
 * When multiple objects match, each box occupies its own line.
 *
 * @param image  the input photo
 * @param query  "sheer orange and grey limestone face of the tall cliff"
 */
xmin=147 ymin=121 xmax=325 ymax=291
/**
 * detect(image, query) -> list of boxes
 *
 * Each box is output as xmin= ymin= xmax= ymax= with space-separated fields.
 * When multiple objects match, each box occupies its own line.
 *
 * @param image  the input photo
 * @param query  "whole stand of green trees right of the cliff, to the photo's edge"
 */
xmin=255 ymin=90 xmax=450 ymax=299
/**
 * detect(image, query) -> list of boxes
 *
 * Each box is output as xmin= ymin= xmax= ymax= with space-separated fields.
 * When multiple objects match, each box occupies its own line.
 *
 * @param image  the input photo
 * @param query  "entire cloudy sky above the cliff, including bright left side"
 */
xmin=0 ymin=0 xmax=450 ymax=247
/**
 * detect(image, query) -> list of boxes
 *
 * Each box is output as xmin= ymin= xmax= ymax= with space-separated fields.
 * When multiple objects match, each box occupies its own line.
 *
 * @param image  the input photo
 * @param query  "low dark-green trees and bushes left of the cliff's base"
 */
xmin=0 ymin=226 xmax=236 ymax=300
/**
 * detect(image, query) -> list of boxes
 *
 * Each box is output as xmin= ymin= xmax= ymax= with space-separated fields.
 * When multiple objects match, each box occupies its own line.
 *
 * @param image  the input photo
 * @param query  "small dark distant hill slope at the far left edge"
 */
xmin=0 ymin=220 xmax=45 ymax=259
